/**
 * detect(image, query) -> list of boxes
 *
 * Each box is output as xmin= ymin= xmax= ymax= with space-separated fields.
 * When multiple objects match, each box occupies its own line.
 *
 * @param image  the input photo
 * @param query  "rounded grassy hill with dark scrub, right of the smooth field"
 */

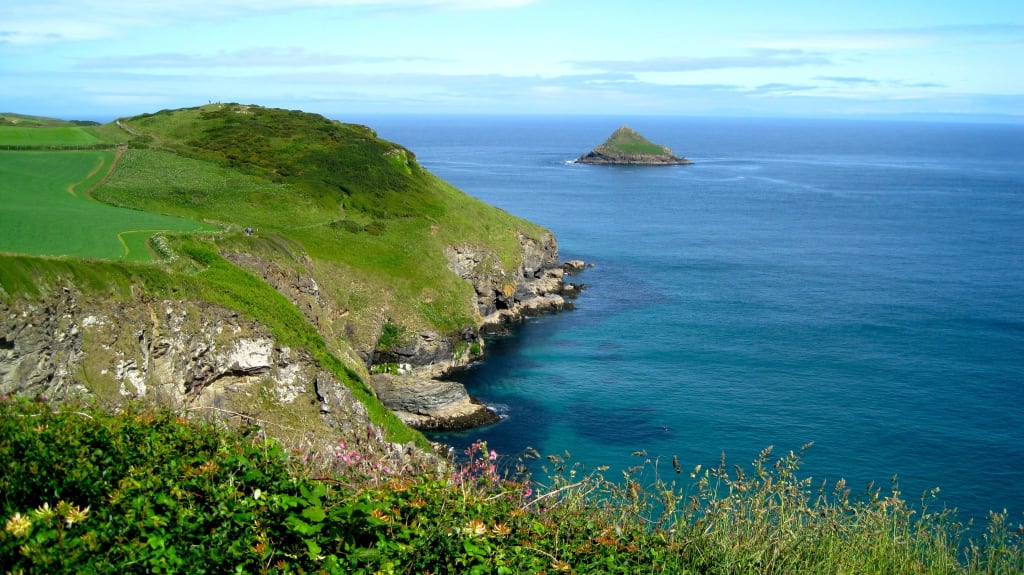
xmin=96 ymin=104 xmax=543 ymax=331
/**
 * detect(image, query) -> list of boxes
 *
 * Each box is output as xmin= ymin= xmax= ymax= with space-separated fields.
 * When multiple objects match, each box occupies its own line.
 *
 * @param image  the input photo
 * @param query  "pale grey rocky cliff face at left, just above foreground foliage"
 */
xmin=0 ymin=288 xmax=422 ymax=469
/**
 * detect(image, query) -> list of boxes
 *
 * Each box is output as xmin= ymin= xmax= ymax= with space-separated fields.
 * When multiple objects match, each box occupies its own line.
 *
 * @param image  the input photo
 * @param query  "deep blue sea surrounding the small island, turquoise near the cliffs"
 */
xmin=354 ymin=117 xmax=1024 ymax=521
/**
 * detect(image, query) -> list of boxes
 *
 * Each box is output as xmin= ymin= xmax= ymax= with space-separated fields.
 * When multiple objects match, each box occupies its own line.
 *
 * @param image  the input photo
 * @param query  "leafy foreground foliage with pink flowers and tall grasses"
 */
xmin=0 ymin=400 xmax=1024 ymax=574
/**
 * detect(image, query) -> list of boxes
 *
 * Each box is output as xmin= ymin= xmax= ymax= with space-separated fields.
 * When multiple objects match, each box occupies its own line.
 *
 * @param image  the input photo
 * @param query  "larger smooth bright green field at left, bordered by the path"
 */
xmin=0 ymin=151 xmax=212 ymax=261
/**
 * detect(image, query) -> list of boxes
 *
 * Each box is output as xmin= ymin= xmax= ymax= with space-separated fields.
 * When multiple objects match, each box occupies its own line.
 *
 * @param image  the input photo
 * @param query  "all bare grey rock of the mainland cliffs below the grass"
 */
xmin=0 ymin=228 xmax=577 ymax=433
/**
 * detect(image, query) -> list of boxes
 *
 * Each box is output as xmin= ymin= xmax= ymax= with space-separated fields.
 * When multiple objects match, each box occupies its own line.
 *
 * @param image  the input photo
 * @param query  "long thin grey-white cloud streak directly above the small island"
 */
xmin=566 ymin=49 xmax=831 ymax=73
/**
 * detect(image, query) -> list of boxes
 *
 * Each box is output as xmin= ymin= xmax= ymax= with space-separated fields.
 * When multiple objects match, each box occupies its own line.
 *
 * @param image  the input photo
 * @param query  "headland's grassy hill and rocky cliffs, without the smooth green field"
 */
xmin=0 ymin=104 xmax=579 ymax=450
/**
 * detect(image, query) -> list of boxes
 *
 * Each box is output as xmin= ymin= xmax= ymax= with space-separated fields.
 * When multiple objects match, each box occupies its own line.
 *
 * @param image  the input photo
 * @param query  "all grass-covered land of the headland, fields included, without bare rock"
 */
xmin=0 ymin=104 xmax=544 ymax=444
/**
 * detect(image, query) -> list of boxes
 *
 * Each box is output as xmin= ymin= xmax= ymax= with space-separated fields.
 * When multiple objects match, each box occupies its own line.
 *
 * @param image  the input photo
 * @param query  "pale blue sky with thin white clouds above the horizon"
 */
xmin=0 ymin=0 xmax=1024 ymax=122
